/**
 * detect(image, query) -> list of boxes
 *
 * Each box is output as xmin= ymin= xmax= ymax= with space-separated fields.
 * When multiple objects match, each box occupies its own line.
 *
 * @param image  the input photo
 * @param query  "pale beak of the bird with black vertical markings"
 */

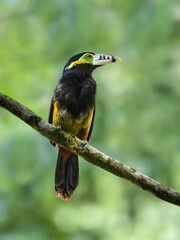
xmin=92 ymin=54 xmax=122 ymax=66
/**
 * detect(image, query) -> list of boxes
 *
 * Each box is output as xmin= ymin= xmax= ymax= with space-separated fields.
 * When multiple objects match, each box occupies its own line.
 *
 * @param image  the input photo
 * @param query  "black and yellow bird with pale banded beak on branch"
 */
xmin=48 ymin=52 xmax=121 ymax=201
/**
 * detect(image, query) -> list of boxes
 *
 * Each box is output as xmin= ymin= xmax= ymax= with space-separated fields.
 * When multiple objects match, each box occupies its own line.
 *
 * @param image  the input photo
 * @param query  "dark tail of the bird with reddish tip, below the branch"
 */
xmin=55 ymin=147 xmax=79 ymax=200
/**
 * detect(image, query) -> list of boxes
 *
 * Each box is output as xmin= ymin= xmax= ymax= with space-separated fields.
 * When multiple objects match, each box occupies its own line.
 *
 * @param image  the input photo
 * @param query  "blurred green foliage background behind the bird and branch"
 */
xmin=0 ymin=0 xmax=180 ymax=240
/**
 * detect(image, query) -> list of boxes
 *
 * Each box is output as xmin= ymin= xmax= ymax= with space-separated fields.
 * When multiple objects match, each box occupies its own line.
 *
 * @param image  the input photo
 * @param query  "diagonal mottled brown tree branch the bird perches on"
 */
xmin=0 ymin=93 xmax=180 ymax=206
